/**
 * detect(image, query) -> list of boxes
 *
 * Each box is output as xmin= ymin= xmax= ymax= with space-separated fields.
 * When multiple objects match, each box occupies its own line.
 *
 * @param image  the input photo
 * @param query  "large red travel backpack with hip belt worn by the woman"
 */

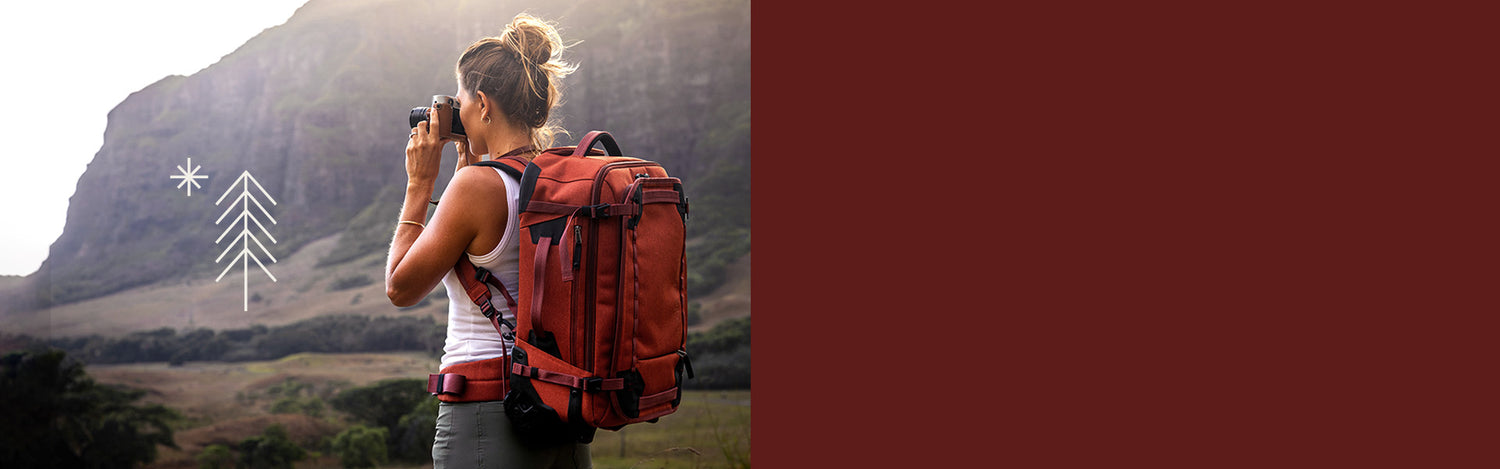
xmin=428 ymin=130 xmax=693 ymax=444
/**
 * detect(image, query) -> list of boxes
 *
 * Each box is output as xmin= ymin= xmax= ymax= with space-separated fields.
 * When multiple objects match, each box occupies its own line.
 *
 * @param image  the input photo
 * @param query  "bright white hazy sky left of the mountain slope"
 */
xmin=0 ymin=0 xmax=306 ymax=276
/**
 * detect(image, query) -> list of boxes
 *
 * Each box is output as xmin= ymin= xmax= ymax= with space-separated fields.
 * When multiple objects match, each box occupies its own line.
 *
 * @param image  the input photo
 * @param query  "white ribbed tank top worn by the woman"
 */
xmin=441 ymin=168 xmax=521 ymax=367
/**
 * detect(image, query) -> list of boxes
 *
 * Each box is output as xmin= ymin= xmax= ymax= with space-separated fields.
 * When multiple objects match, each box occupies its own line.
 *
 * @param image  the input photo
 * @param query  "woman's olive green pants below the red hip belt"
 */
xmin=432 ymin=400 xmax=594 ymax=469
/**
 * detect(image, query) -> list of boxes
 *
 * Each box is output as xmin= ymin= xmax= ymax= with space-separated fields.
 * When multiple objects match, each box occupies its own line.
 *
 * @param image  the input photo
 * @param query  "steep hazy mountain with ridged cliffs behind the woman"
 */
xmin=0 ymin=0 xmax=750 ymax=323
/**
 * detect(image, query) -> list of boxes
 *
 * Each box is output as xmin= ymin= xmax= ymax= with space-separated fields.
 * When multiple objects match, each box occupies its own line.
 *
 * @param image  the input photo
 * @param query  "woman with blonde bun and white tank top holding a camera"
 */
xmin=386 ymin=13 xmax=591 ymax=469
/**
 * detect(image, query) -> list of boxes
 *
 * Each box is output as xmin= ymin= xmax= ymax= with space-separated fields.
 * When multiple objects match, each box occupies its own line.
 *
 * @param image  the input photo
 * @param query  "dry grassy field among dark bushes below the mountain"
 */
xmin=89 ymin=354 xmax=750 ymax=469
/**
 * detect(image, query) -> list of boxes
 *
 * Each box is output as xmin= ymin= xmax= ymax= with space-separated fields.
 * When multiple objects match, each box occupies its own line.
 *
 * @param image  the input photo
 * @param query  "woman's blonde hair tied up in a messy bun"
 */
xmin=455 ymin=13 xmax=578 ymax=150
